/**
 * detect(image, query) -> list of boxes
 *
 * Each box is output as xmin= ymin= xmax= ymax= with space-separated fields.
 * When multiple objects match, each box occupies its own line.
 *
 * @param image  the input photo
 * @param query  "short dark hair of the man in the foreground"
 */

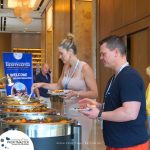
xmin=99 ymin=35 xmax=127 ymax=55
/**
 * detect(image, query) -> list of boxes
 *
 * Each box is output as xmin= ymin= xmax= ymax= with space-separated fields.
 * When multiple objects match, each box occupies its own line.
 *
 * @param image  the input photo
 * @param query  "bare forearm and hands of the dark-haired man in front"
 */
xmin=79 ymin=99 xmax=141 ymax=122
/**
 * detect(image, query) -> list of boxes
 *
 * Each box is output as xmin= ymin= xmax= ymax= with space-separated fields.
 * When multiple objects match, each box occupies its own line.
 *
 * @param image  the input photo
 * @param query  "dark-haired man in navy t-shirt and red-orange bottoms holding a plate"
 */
xmin=79 ymin=36 xmax=148 ymax=150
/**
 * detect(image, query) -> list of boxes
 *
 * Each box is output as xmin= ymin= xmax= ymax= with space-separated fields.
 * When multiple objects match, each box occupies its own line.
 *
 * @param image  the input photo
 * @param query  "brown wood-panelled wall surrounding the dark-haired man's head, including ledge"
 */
xmin=97 ymin=0 xmax=150 ymax=99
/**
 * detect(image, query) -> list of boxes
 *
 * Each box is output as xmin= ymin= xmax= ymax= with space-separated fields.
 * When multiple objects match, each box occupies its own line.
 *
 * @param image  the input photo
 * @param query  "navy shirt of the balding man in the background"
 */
xmin=35 ymin=72 xmax=51 ymax=98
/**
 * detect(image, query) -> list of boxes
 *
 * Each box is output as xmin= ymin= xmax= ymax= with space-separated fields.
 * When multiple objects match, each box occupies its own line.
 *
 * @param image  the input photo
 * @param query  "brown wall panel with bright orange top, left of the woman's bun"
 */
xmin=53 ymin=0 xmax=70 ymax=82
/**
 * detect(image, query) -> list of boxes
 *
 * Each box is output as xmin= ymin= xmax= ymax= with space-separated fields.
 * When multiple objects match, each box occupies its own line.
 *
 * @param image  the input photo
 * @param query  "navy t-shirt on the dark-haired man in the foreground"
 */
xmin=103 ymin=66 xmax=148 ymax=148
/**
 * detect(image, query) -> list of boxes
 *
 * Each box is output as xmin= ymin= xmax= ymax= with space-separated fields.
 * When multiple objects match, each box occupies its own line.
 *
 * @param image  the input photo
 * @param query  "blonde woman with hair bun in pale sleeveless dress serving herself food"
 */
xmin=33 ymin=34 xmax=98 ymax=149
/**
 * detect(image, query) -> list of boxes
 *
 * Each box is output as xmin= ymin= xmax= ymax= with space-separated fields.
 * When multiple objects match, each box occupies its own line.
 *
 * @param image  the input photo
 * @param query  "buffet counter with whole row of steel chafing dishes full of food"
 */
xmin=0 ymin=97 xmax=81 ymax=150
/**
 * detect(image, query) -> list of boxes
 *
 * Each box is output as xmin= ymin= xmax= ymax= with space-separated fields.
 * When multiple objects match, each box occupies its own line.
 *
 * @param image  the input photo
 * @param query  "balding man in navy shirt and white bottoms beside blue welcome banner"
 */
xmin=35 ymin=63 xmax=51 ymax=108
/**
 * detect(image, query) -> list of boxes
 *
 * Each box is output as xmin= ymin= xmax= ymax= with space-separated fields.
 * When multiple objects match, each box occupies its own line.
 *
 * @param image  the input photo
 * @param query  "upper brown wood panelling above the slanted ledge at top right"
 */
xmin=99 ymin=0 xmax=150 ymax=39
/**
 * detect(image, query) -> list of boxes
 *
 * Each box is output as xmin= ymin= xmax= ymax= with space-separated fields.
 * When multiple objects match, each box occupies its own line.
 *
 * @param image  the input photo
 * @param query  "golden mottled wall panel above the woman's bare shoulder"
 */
xmin=73 ymin=1 xmax=92 ymax=66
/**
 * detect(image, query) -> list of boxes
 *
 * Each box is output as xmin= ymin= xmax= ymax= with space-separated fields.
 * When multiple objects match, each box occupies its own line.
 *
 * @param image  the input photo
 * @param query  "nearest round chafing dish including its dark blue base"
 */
xmin=0 ymin=114 xmax=81 ymax=150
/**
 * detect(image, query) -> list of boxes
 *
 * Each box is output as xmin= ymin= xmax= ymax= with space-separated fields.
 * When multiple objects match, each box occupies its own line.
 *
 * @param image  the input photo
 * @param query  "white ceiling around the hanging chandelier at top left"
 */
xmin=0 ymin=0 xmax=51 ymax=33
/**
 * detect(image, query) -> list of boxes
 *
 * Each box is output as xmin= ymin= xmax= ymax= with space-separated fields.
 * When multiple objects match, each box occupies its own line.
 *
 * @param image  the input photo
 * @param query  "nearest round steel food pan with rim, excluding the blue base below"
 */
xmin=2 ymin=115 xmax=73 ymax=138
